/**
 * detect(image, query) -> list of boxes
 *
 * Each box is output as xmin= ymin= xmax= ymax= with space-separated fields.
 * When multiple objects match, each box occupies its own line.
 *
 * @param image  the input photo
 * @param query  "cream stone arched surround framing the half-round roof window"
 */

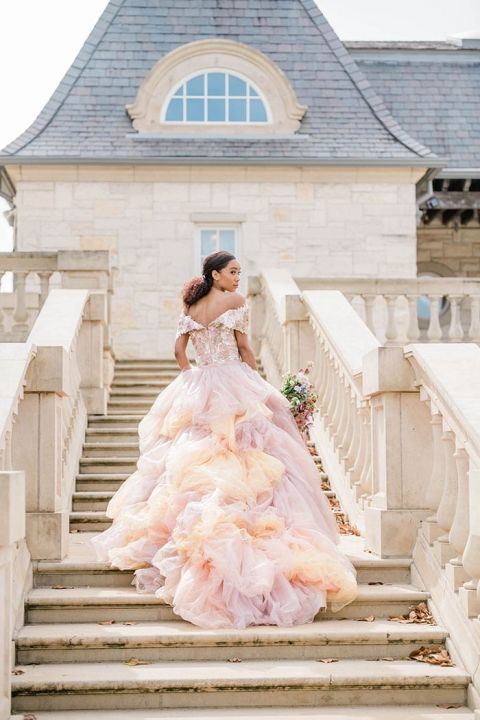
xmin=126 ymin=39 xmax=307 ymax=137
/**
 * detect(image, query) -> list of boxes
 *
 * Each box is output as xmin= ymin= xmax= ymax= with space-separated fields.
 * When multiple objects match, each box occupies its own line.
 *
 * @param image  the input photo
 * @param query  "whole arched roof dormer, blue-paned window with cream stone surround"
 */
xmin=127 ymin=39 xmax=307 ymax=136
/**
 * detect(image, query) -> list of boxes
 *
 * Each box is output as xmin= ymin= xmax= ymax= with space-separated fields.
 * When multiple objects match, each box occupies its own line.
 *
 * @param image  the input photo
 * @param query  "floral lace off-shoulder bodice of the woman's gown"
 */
xmin=176 ymin=305 xmax=248 ymax=365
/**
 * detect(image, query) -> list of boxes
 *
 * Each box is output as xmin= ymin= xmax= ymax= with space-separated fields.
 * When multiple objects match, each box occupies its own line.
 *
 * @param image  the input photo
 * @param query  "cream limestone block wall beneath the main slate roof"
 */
xmin=11 ymin=166 xmax=421 ymax=357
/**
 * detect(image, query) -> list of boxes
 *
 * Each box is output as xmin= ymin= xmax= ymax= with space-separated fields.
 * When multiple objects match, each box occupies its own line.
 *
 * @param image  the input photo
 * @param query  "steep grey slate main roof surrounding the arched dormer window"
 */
xmin=0 ymin=0 xmax=442 ymax=166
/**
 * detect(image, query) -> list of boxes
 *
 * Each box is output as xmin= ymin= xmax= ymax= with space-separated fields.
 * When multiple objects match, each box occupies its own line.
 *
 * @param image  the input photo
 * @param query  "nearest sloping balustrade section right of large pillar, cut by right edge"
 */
xmin=405 ymin=343 xmax=480 ymax=616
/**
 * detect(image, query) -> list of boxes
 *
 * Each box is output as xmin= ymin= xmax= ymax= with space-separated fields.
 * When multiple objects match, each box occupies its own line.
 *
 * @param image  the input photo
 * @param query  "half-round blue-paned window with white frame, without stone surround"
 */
xmin=162 ymin=69 xmax=269 ymax=124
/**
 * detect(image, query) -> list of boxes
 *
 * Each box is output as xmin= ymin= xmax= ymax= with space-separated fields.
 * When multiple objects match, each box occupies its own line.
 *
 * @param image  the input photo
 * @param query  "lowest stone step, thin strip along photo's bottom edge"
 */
xmin=11 ymin=705 xmax=475 ymax=720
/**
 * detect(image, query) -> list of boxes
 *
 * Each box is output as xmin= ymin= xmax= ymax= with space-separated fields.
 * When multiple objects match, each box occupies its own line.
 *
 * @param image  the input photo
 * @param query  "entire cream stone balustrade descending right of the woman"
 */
xmin=250 ymin=271 xmax=480 ymax=699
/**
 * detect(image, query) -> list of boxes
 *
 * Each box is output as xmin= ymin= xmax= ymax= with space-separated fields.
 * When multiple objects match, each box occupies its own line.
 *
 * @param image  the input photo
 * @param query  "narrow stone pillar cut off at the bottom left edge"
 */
xmin=0 ymin=472 xmax=25 ymax=720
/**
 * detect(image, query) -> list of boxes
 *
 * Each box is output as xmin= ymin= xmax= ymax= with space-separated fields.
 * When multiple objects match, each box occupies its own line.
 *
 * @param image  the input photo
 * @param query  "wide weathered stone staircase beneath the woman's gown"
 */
xmin=9 ymin=360 xmax=474 ymax=720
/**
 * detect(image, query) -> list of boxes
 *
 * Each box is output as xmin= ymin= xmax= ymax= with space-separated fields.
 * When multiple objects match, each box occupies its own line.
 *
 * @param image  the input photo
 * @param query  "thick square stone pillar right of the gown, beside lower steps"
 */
xmin=363 ymin=347 xmax=431 ymax=557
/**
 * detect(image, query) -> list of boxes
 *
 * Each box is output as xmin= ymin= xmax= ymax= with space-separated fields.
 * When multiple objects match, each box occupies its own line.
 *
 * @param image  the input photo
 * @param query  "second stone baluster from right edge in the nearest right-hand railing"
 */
xmin=446 ymin=448 xmax=470 ymax=590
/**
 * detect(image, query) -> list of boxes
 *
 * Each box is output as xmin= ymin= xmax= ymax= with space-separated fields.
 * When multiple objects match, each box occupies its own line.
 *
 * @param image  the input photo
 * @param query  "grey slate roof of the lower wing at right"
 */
xmin=345 ymin=40 xmax=480 ymax=170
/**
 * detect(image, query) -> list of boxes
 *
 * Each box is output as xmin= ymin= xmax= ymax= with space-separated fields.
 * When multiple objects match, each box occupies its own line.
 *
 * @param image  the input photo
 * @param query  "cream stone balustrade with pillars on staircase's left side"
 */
xmin=0 ymin=290 xmax=107 ymax=559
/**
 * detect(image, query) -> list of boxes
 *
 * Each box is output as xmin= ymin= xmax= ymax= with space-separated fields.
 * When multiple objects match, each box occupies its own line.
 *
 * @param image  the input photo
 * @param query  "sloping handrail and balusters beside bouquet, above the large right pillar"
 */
xmin=303 ymin=291 xmax=379 ymax=529
